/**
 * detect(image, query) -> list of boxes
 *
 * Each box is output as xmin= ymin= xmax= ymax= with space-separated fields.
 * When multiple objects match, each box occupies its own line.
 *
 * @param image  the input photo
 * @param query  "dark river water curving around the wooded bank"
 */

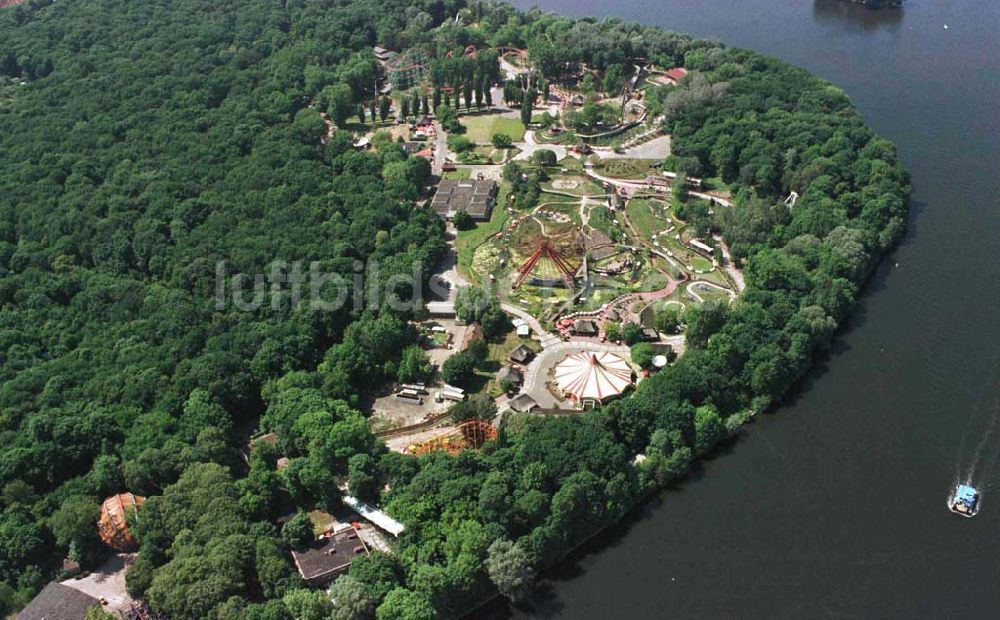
xmin=488 ymin=0 xmax=1000 ymax=619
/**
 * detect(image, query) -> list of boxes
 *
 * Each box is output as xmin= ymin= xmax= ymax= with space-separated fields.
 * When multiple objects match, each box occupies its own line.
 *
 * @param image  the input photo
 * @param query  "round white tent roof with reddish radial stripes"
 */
xmin=555 ymin=351 xmax=632 ymax=402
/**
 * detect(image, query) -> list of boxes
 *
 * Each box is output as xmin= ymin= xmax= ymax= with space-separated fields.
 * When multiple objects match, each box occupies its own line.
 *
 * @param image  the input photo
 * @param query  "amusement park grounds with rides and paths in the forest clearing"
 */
xmin=361 ymin=37 xmax=743 ymax=464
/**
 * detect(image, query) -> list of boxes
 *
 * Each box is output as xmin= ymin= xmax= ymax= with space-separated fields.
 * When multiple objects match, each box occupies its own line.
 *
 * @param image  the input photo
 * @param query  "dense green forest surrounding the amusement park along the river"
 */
xmin=0 ymin=0 xmax=909 ymax=619
